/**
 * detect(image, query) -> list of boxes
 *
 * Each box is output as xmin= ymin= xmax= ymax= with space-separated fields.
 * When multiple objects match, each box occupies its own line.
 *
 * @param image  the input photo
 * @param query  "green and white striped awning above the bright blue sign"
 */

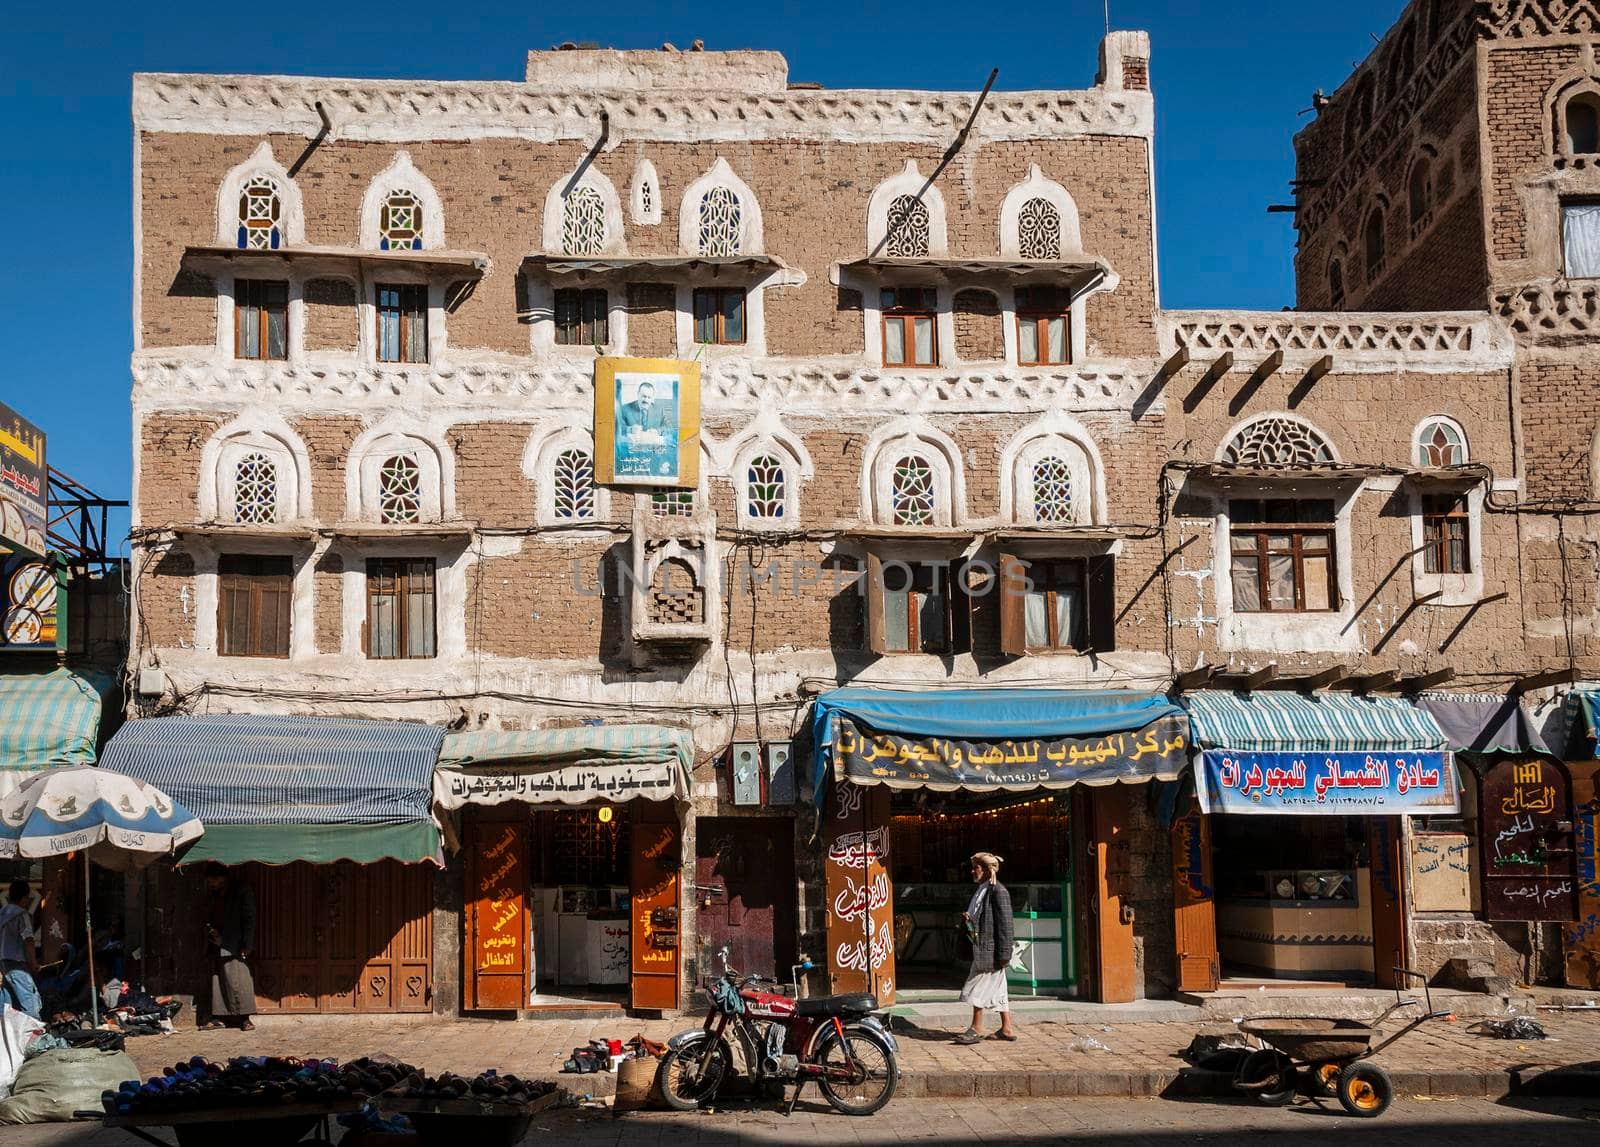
xmin=1181 ymin=691 xmax=1450 ymax=752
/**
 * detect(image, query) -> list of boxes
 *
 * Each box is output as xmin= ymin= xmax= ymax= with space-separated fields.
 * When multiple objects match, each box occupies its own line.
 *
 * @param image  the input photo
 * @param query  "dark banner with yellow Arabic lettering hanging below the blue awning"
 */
xmin=832 ymin=713 xmax=1189 ymax=792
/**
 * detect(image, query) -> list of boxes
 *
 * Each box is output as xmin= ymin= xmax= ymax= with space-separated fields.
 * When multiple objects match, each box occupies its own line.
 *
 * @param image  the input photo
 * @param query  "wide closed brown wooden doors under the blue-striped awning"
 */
xmin=246 ymin=861 xmax=434 ymax=1013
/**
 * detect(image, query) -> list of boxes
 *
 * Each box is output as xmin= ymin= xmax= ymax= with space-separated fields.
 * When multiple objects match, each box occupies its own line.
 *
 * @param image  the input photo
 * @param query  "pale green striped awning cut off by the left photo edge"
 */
xmin=0 ymin=669 xmax=110 ymax=797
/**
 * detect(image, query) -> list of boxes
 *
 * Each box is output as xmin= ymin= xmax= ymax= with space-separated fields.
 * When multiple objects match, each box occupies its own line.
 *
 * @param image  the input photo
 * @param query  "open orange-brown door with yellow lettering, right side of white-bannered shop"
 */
xmin=629 ymin=800 xmax=683 ymax=1009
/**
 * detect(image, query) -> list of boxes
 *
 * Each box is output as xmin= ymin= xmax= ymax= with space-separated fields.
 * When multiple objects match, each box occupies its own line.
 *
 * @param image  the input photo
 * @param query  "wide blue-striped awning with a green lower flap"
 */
xmin=101 ymin=713 xmax=445 ymax=864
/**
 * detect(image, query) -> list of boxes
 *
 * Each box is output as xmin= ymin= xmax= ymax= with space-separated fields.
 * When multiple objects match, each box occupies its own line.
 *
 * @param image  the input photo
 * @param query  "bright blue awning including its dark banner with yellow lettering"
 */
xmin=811 ymin=688 xmax=1189 ymax=800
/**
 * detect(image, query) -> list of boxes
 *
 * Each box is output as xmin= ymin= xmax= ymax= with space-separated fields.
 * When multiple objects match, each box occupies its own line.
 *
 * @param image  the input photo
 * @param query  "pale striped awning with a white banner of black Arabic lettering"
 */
xmin=434 ymin=725 xmax=694 ymax=809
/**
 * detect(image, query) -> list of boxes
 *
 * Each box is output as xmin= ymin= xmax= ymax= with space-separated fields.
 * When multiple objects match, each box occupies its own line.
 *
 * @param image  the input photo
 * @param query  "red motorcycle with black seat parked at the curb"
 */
xmin=656 ymin=949 xmax=899 ymax=1115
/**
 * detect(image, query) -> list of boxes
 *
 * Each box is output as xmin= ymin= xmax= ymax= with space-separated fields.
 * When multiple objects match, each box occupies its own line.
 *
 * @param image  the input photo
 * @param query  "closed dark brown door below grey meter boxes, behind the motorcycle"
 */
xmin=694 ymin=816 xmax=795 ymax=981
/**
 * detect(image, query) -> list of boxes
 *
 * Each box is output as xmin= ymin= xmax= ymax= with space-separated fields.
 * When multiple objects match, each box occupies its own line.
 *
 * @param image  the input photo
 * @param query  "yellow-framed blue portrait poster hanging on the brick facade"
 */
xmin=595 ymin=358 xmax=699 ymax=490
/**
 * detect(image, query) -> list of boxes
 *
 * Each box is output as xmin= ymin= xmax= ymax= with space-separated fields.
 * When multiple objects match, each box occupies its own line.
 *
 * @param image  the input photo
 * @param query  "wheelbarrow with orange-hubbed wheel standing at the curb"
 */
xmin=1234 ymin=968 xmax=1450 ymax=1120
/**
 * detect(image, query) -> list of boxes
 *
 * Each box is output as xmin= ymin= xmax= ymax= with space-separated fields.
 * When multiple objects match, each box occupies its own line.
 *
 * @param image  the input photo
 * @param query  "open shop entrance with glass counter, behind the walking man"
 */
xmin=890 ymin=790 xmax=1078 ymax=995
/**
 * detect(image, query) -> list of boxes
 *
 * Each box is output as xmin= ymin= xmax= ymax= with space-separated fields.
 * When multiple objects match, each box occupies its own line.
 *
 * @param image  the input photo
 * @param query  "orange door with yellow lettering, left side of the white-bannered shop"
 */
xmin=461 ymin=819 xmax=528 ymax=1011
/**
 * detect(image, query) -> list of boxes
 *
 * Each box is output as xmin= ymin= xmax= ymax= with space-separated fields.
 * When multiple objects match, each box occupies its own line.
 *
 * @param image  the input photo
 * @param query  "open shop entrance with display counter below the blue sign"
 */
xmin=1208 ymin=813 xmax=1405 ymax=987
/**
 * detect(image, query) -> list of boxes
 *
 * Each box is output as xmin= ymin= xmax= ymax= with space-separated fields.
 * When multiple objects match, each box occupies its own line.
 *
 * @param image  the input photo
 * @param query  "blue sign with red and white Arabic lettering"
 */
xmin=1198 ymin=749 xmax=1461 ymax=816
